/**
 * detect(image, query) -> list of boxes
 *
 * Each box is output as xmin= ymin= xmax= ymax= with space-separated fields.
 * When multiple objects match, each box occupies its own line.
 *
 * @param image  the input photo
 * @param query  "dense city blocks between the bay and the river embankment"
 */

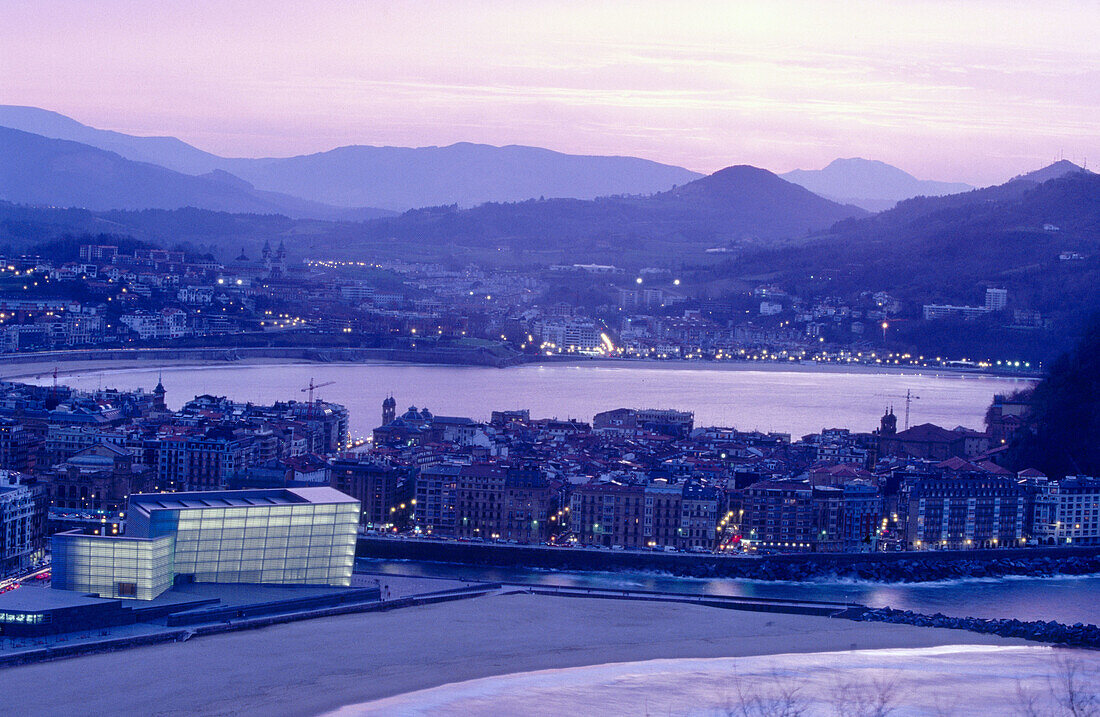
xmin=0 ymin=369 xmax=1100 ymax=589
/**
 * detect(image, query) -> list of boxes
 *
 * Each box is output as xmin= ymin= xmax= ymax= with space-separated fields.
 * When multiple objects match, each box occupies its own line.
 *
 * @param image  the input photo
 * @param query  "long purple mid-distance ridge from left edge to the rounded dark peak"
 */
xmin=0 ymin=160 xmax=866 ymax=265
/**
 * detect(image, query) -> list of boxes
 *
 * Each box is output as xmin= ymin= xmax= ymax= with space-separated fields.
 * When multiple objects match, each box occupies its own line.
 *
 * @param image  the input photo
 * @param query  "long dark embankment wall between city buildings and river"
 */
xmin=356 ymin=537 xmax=1100 ymax=583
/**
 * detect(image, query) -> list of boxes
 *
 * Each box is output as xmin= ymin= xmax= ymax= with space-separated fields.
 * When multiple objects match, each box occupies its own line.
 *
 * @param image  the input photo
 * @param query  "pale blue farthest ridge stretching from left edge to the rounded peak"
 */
xmin=0 ymin=106 xmax=702 ymax=211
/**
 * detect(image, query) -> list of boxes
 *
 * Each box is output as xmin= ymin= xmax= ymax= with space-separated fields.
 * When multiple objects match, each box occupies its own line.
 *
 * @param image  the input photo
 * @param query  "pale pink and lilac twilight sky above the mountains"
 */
xmin=0 ymin=0 xmax=1100 ymax=185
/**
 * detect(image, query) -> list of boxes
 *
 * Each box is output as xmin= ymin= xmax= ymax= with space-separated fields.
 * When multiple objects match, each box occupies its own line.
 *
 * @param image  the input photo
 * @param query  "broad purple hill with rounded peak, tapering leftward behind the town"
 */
xmin=330 ymin=166 xmax=866 ymax=265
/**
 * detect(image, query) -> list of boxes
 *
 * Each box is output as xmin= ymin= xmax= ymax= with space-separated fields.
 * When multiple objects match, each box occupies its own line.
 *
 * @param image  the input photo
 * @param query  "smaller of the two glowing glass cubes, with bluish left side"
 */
xmin=51 ymin=532 xmax=174 ymax=600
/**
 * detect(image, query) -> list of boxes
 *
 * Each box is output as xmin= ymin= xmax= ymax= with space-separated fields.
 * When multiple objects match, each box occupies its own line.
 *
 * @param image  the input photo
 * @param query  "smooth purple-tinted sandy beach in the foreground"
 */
xmin=0 ymin=594 xmax=1033 ymax=716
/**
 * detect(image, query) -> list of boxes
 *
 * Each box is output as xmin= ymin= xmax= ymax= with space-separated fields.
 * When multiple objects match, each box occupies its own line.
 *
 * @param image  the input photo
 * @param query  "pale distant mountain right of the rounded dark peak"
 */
xmin=780 ymin=157 xmax=974 ymax=211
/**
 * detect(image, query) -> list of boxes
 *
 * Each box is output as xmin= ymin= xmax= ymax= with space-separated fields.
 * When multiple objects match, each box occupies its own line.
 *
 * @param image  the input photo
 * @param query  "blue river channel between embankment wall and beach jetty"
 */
xmin=365 ymin=559 xmax=1100 ymax=625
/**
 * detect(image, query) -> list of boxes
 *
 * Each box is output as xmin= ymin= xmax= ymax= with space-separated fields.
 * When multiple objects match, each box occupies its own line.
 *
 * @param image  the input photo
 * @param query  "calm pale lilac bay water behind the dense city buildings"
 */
xmin=17 ymin=363 xmax=1030 ymax=437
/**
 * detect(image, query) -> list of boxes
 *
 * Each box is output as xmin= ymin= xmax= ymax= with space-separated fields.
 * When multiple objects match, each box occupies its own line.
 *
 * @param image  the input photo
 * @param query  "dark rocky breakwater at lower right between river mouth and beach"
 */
xmin=845 ymin=607 xmax=1100 ymax=649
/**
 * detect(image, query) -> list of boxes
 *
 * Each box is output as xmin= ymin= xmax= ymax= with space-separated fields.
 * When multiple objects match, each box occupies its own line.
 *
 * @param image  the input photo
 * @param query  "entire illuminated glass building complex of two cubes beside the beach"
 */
xmin=52 ymin=487 xmax=359 ymax=599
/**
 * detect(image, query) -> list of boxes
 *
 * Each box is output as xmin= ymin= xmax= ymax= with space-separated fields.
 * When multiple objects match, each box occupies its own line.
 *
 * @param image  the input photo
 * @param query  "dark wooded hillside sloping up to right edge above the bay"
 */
xmin=726 ymin=172 xmax=1100 ymax=349
